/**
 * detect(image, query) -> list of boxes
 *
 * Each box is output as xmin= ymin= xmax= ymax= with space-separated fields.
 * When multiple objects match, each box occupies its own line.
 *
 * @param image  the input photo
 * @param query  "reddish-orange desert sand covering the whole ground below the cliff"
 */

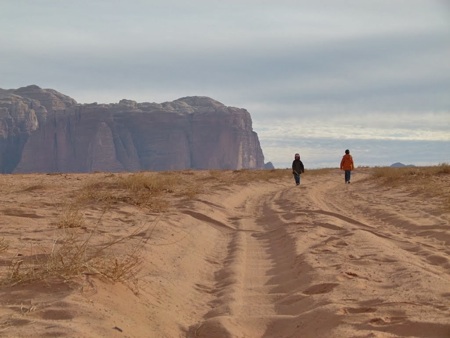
xmin=0 ymin=168 xmax=450 ymax=338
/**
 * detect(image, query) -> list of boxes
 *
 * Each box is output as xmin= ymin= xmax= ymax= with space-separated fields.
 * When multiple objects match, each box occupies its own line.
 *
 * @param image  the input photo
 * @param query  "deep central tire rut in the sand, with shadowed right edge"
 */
xmin=188 ymin=187 xmax=304 ymax=337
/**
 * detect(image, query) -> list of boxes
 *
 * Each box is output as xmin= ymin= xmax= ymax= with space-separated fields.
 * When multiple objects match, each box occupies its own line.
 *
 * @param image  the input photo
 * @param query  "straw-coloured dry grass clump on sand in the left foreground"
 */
xmin=0 ymin=210 xmax=144 ymax=285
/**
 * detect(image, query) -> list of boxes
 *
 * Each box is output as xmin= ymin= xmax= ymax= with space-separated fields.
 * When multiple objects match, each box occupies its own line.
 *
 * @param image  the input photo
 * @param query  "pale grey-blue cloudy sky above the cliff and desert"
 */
xmin=0 ymin=0 xmax=450 ymax=168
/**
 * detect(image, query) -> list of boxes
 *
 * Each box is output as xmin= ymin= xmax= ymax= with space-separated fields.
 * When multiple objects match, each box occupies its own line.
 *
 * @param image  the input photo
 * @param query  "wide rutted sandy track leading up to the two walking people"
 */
xmin=184 ymin=172 xmax=450 ymax=337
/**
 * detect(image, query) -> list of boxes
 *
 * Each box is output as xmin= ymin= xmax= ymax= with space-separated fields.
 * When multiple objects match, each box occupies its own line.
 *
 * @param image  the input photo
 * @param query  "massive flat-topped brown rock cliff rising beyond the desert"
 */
xmin=0 ymin=86 xmax=264 ymax=173
